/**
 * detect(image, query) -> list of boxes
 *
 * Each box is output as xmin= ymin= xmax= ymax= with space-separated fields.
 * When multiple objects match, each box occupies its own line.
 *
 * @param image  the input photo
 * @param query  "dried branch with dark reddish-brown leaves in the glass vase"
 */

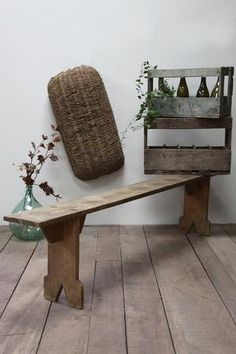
xmin=15 ymin=125 xmax=61 ymax=200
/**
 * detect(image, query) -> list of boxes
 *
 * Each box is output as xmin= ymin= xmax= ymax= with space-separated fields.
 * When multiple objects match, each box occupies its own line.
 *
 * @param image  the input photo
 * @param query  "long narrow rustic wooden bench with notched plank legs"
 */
xmin=4 ymin=175 xmax=210 ymax=309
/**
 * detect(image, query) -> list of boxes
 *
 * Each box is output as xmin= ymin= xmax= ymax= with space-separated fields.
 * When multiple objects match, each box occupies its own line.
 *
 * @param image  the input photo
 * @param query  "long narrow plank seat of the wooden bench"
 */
xmin=4 ymin=175 xmax=201 ymax=227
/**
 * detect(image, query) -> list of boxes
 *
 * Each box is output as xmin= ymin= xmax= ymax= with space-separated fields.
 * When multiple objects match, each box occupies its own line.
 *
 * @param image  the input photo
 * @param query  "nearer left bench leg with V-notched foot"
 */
xmin=43 ymin=217 xmax=85 ymax=309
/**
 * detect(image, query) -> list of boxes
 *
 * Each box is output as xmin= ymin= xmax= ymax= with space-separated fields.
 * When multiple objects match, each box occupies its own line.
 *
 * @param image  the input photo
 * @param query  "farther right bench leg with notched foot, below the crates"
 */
xmin=179 ymin=177 xmax=210 ymax=236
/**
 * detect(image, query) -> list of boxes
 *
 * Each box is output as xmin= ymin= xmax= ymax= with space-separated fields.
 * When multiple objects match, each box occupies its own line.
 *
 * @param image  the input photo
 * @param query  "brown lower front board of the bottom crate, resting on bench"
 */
xmin=144 ymin=148 xmax=231 ymax=173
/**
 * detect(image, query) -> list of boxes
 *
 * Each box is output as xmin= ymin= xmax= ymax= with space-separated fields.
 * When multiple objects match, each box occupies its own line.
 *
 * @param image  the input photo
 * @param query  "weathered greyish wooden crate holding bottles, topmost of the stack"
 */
xmin=148 ymin=67 xmax=234 ymax=118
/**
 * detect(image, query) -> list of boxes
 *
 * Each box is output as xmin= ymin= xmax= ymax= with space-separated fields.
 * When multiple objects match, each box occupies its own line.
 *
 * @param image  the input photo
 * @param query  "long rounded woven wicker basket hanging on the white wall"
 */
xmin=48 ymin=66 xmax=124 ymax=180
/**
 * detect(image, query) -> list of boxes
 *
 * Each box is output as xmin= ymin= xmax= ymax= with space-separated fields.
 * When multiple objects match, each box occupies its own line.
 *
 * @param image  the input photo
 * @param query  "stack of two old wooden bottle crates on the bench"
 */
xmin=144 ymin=67 xmax=234 ymax=176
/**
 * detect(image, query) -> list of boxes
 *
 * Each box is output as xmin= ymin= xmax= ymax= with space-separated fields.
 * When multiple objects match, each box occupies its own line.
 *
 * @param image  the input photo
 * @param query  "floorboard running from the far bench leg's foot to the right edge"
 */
xmin=188 ymin=233 xmax=236 ymax=323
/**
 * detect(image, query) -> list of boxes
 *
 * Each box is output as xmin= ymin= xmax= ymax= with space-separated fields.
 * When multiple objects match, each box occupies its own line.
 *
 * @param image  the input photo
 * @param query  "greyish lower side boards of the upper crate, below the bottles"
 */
xmin=155 ymin=97 xmax=231 ymax=119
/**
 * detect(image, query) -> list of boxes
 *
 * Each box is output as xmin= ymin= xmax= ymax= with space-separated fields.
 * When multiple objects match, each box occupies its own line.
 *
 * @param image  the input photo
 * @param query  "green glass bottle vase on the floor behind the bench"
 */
xmin=9 ymin=186 xmax=44 ymax=241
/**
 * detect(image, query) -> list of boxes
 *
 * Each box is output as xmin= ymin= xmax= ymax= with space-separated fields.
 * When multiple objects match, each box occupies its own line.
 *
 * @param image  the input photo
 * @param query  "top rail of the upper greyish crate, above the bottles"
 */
xmin=148 ymin=67 xmax=233 ymax=78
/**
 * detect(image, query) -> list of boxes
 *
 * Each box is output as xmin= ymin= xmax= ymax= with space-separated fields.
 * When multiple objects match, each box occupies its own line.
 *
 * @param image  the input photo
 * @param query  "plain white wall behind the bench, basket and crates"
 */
xmin=0 ymin=0 xmax=236 ymax=224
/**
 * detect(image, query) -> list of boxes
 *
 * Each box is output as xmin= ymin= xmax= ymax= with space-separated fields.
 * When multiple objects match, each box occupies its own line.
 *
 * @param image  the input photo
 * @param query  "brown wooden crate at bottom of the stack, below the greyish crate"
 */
xmin=144 ymin=117 xmax=232 ymax=175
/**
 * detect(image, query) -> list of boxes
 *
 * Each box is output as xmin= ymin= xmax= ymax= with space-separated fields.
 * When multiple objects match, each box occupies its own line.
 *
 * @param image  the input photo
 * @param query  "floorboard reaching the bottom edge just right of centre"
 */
xmin=123 ymin=262 xmax=175 ymax=354
